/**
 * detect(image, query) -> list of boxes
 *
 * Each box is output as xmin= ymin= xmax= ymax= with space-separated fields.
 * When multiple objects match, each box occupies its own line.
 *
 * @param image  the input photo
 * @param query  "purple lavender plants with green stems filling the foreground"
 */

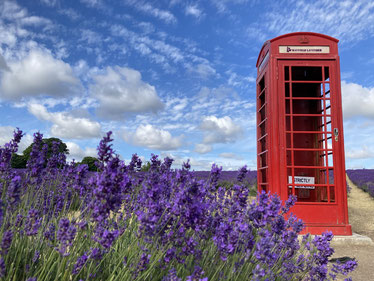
xmin=0 ymin=130 xmax=357 ymax=281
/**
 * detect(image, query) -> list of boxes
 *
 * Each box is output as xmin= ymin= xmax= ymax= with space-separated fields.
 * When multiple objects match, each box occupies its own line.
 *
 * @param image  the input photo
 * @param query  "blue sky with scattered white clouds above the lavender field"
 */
xmin=0 ymin=0 xmax=374 ymax=170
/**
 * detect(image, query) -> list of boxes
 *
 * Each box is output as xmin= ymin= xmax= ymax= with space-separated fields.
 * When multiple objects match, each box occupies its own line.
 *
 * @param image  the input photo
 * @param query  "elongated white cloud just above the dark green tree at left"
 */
xmin=28 ymin=104 xmax=101 ymax=139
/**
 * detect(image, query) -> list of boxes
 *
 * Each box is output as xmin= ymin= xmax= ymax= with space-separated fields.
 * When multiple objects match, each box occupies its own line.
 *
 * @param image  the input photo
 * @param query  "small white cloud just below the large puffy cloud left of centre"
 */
xmin=124 ymin=124 xmax=183 ymax=150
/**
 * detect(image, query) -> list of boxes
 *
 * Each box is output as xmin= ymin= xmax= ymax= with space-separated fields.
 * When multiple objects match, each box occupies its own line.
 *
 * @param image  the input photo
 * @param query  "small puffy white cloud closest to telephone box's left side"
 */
xmin=200 ymin=116 xmax=242 ymax=144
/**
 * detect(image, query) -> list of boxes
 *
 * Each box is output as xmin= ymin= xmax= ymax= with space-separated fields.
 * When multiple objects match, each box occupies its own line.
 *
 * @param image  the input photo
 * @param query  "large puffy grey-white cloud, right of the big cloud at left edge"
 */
xmin=91 ymin=67 xmax=164 ymax=118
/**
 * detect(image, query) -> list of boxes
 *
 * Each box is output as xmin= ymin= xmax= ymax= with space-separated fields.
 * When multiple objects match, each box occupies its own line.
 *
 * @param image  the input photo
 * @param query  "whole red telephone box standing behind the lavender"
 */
xmin=256 ymin=32 xmax=352 ymax=235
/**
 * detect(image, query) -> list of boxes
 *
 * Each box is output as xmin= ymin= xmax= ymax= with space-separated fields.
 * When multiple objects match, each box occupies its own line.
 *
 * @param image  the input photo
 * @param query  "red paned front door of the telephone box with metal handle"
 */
xmin=277 ymin=60 xmax=345 ymax=225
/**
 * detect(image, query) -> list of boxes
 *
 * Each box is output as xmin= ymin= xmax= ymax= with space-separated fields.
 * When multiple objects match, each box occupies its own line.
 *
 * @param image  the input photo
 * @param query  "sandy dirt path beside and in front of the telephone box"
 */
xmin=333 ymin=178 xmax=374 ymax=281
